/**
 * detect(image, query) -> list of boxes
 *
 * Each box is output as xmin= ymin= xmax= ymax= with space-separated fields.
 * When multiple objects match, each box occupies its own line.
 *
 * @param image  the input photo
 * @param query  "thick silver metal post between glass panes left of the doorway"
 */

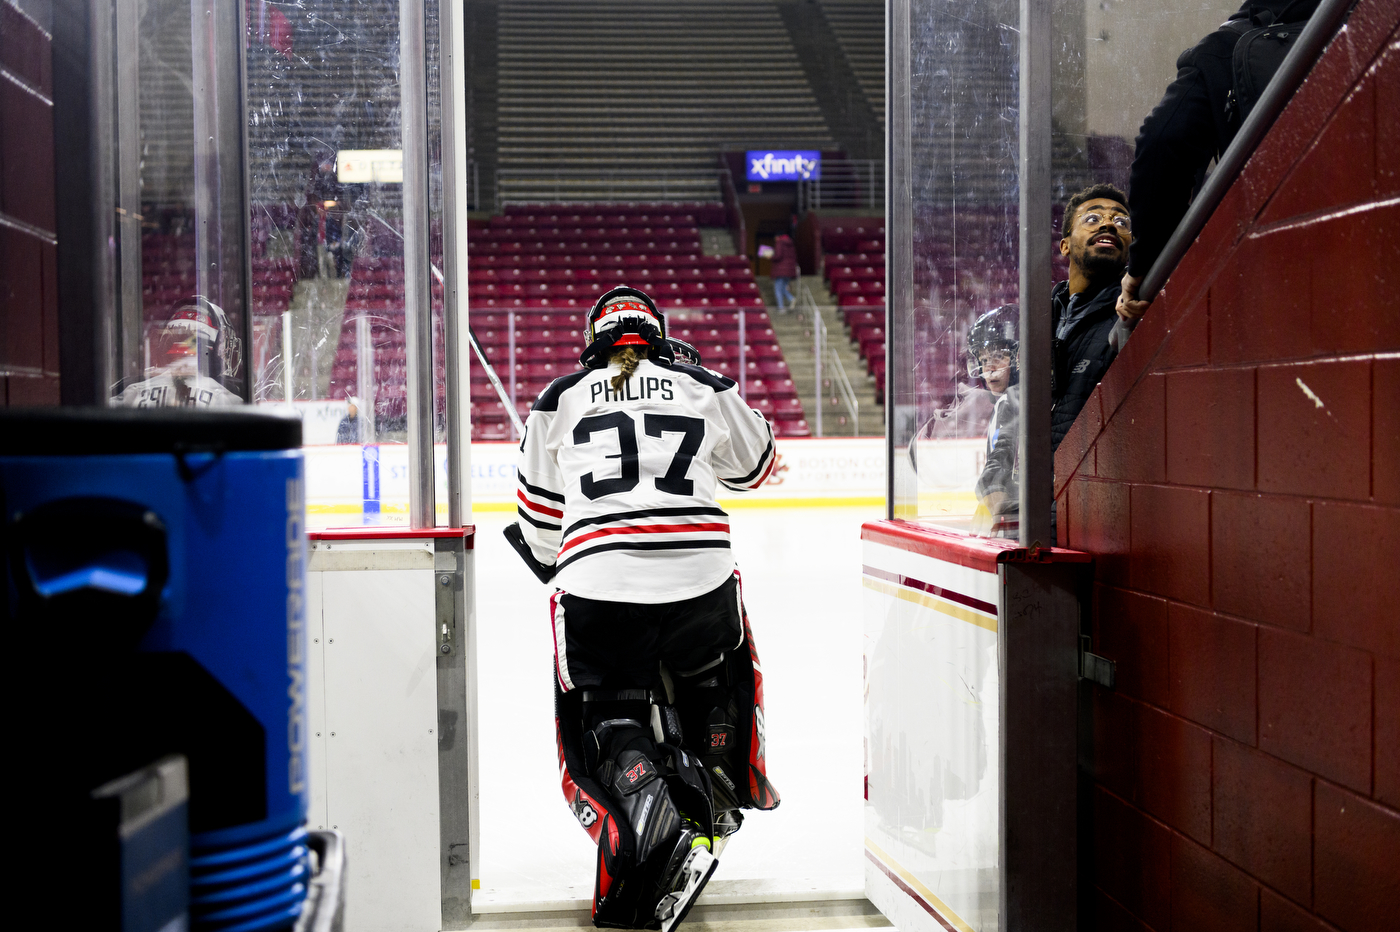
xmin=399 ymin=0 xmax=437 ymax=528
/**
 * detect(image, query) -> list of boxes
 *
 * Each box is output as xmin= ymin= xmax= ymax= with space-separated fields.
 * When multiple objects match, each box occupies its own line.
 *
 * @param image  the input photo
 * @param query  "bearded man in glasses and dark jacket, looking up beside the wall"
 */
xmin=1050 ymin=185 xmax=1133 ymax=449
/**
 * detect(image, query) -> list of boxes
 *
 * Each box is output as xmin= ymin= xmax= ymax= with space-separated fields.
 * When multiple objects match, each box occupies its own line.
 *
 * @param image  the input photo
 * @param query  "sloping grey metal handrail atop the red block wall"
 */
xmin=1138 ymin=0 xmax=1357 ymax=301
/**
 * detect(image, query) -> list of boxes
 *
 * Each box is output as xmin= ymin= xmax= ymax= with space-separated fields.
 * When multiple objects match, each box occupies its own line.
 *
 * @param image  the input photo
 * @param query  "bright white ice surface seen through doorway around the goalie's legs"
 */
xmin=473 ymin=508 xmax=883 ymax=910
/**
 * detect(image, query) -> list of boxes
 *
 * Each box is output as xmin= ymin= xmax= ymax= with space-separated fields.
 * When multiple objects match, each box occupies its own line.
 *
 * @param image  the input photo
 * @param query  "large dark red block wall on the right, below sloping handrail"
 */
xmin=1056 ymin=0 xmax=1400 ymax=932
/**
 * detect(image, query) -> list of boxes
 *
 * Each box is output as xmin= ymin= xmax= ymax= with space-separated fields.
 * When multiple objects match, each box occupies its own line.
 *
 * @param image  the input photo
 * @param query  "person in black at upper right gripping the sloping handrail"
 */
xmin=1117 ymin=0 xmax=1320 ymax=322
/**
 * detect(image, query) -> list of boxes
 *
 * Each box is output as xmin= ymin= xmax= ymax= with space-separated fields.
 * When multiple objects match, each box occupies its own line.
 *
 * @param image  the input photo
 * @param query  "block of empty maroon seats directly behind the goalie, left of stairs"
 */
xmin=330 ymin=203 xmax=809 ymax=439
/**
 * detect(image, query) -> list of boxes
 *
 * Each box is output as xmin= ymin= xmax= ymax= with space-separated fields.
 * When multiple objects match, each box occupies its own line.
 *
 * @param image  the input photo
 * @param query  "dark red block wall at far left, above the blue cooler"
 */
xmin=0 ymin=0 xmax=59 ymax=404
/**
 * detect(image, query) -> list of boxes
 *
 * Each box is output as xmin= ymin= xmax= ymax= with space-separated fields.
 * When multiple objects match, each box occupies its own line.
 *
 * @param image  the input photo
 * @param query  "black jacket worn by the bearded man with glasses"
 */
xmin=1050 ymin=280 xmax=1119 ymax=449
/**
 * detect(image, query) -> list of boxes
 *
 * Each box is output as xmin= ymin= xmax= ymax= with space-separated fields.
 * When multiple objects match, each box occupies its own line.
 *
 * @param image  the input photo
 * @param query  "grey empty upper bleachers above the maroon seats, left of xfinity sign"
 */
xmin=497 ymin=0 xmax=836 ymax=202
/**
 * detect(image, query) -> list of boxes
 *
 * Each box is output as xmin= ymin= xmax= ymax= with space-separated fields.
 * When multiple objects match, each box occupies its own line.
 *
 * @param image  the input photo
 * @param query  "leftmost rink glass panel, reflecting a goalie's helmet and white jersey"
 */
xmin=109 ymin=0 xmax=249 ymax=407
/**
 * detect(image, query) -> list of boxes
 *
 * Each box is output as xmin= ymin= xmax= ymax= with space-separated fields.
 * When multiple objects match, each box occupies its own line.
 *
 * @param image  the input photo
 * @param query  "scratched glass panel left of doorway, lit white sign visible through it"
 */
xmin=246 ymin=0 xmax=447 ymax=526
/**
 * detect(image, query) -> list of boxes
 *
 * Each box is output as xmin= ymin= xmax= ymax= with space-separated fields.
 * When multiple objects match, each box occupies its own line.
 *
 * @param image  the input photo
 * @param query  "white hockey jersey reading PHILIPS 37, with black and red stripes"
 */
xmin=517 ymin=355 xmax=776 ymax=605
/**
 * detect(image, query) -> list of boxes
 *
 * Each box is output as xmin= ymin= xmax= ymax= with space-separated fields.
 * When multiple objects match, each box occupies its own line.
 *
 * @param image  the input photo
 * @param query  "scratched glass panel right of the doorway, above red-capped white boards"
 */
xmin=886 ymin=0 xmax=1018 ymax=532
